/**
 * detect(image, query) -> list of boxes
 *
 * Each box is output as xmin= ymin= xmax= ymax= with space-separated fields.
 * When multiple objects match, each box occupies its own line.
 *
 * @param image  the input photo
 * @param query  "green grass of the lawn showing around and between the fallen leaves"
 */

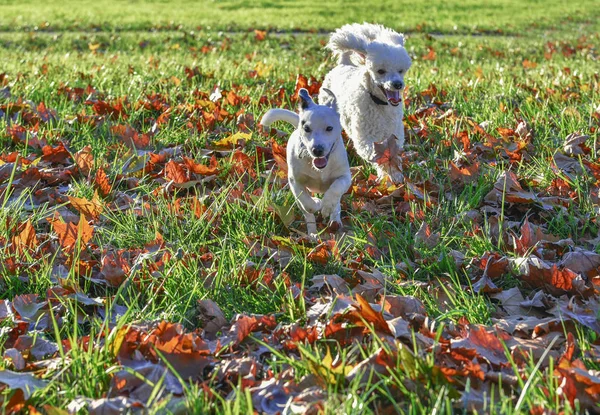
xmin=0 ymin=0 xmax=600 ymax=414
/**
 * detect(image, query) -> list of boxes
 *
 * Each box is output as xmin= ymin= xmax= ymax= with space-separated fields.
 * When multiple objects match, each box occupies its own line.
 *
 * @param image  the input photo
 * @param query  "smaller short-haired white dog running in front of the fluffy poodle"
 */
xmin=260 ymin=88 xmax=352 ymax=237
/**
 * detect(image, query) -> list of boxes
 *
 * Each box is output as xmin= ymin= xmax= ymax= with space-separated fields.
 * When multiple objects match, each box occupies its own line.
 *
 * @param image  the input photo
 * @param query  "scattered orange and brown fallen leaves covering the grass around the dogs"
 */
xmin=0 ymin=20 xmax=600 ymax=414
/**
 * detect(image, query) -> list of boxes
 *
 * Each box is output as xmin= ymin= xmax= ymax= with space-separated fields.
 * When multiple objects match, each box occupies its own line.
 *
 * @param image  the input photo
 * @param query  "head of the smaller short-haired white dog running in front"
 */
xmin=298 ymin=88 xmax=342 ymax=170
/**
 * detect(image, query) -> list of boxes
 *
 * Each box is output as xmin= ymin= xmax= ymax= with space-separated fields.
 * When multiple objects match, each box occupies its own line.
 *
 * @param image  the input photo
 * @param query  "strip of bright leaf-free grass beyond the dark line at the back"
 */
xmin=0 ymin=0 xmax=598 ymax=34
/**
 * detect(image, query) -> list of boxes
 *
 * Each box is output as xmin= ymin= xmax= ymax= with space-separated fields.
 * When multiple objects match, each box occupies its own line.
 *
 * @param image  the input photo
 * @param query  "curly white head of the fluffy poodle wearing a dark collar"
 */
xmin=363 ymin=41 xmax=412 ymax=106
